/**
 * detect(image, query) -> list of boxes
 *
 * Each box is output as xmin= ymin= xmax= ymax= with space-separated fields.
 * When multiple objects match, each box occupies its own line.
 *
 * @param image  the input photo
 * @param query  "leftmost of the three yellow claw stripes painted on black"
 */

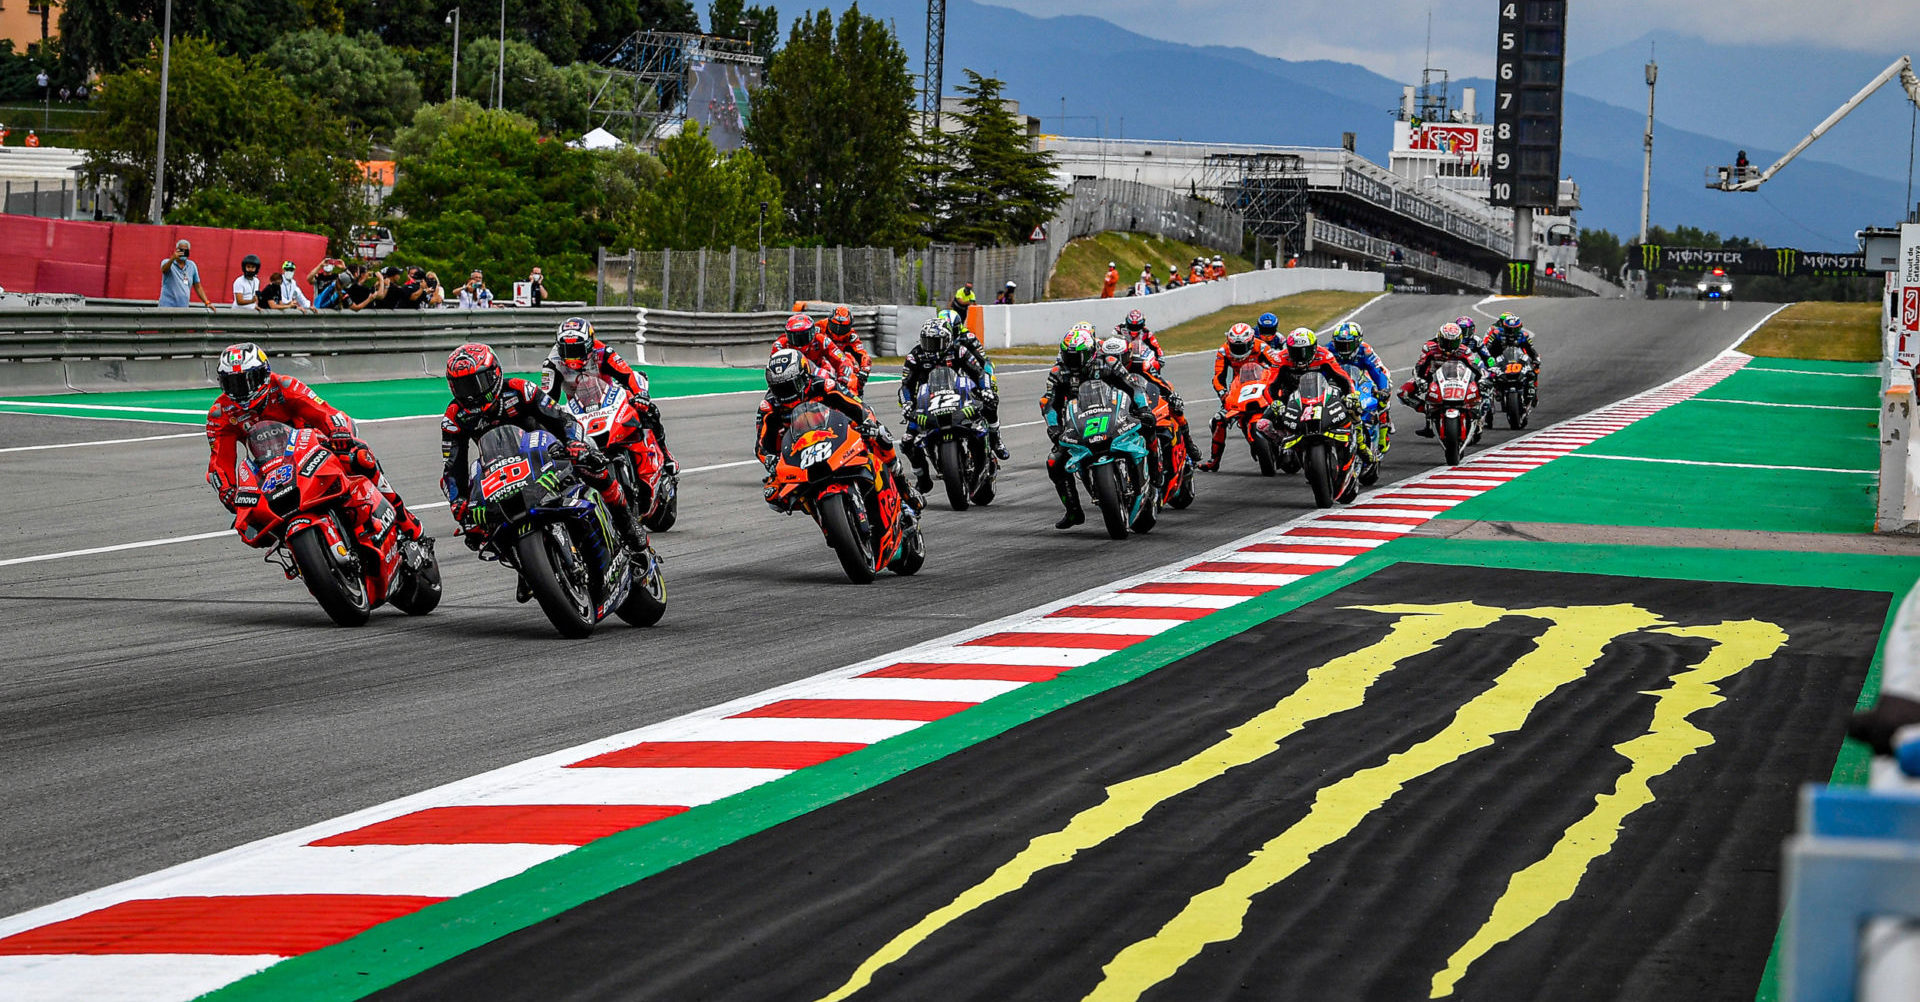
xmin=822 ymin=603 xmax=1507 ymax=1002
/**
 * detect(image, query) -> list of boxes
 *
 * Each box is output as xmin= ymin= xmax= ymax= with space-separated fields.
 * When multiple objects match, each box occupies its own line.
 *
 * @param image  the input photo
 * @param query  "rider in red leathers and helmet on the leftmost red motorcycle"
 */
xmin=207 ymin=342 xmax=426 ymax=539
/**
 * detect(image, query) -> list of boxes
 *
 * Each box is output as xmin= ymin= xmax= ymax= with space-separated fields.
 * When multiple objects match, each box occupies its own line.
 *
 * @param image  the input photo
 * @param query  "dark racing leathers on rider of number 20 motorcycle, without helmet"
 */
xmin=440 ymin=376 xmax=645 ymax=553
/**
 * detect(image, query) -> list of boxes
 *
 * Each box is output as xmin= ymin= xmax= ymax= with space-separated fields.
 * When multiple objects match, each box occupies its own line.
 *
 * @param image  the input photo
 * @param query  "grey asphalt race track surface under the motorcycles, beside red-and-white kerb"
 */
xmin=0 ymin=298 xmax=1772 ymax=914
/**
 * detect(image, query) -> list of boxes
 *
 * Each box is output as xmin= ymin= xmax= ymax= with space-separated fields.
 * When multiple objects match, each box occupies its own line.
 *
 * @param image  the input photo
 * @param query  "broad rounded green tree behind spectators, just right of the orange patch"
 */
xmin=388 ymin=109 xmax=622 ymax=299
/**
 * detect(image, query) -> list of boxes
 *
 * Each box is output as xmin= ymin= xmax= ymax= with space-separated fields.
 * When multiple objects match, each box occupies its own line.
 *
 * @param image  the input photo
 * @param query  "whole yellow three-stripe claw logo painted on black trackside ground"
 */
xmin=822 ymin=601 xmax=1788 ymax=1002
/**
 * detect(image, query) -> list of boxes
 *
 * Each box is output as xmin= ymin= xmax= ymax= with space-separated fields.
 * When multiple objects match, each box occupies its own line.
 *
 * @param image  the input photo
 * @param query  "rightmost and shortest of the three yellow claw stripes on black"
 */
xmin=1432 ymin=620 xmax=1788 ymax=998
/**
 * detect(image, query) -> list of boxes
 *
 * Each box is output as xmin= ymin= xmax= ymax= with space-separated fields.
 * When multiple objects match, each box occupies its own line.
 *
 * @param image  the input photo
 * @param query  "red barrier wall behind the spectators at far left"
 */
xmin=0 ymin=215 xmax=326 ymax=303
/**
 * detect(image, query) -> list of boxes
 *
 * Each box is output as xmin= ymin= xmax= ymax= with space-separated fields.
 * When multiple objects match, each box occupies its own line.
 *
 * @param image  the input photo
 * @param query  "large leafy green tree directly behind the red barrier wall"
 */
xmin=81 ymin=38 xmax=367 ymax=248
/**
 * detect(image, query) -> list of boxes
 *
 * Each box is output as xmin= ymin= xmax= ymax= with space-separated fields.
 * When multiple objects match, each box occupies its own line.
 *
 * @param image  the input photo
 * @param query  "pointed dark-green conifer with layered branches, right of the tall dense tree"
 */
xmin=933 ymin=69 xmax=1068 ymax=244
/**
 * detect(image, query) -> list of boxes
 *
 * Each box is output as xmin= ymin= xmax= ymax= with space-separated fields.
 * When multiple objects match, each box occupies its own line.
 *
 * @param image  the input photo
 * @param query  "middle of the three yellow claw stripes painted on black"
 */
xmin=1087 ymin=605 xmax=1667 ymax=1002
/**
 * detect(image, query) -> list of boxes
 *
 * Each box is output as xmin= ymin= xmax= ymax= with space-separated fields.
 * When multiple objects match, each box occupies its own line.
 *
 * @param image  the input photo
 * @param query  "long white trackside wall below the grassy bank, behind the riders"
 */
xmin=972 ymin=269 xmax=1386 ymax=347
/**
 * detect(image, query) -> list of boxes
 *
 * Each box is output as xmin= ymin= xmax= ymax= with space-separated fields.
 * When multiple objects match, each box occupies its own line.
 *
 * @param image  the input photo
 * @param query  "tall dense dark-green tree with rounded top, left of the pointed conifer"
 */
xmin=747 ymin=4 xmax=920 ymax=246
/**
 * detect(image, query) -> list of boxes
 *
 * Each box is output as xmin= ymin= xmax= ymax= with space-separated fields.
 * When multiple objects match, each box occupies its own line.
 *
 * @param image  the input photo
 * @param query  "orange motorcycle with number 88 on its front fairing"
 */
xmin=766 ymin=403 xmax=927 ymax=584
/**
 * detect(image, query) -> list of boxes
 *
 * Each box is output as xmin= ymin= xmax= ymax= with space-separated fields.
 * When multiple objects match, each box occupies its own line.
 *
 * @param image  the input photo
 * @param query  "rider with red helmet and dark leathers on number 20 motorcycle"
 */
xmin=440 ymin=342 xmax=647 ymax=552
